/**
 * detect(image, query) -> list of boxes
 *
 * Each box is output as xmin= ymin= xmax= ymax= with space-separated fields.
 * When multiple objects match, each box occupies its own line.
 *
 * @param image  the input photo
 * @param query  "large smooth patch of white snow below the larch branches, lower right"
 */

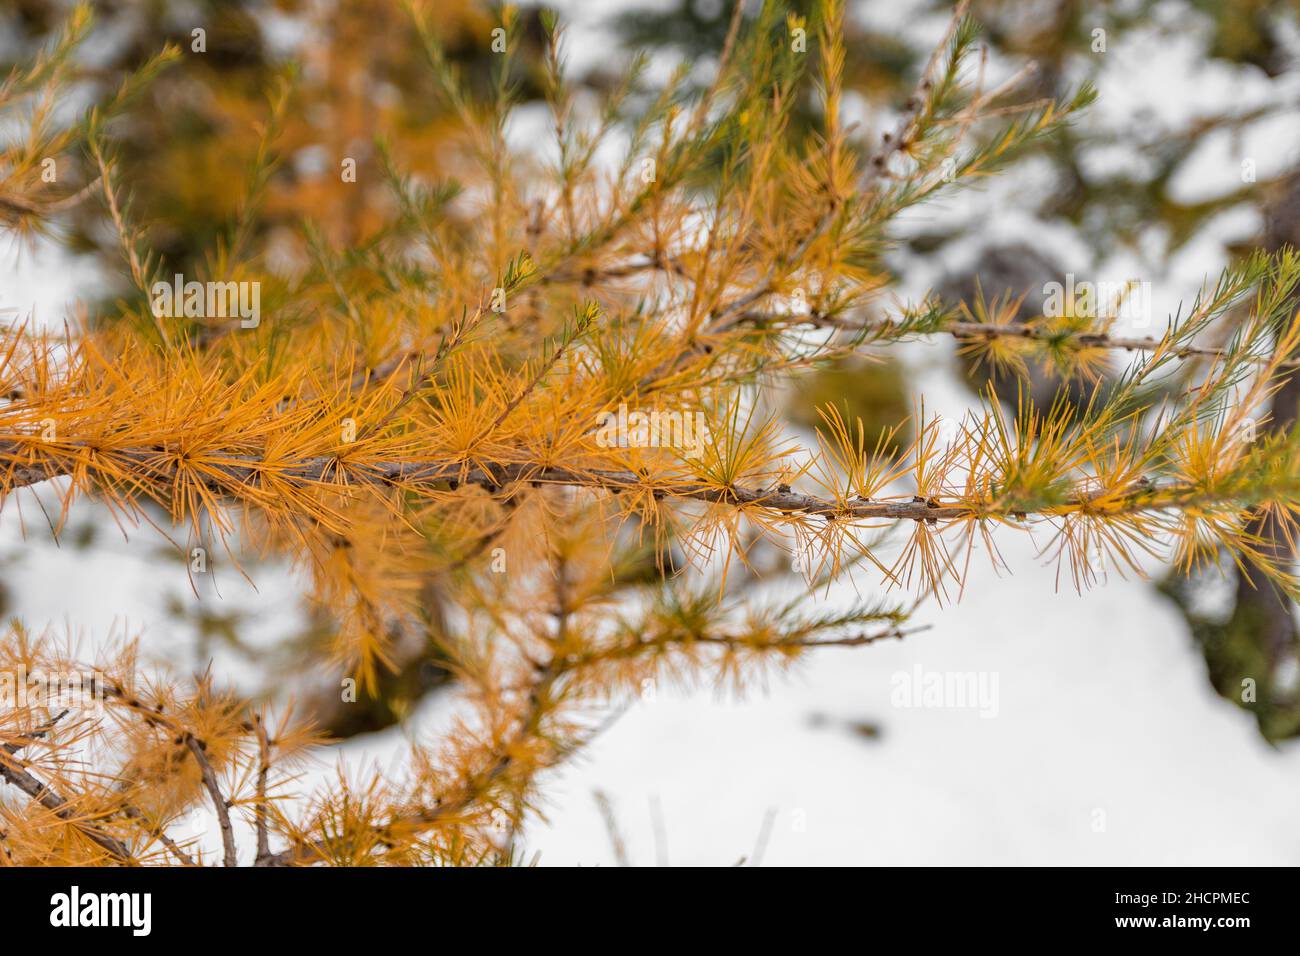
xmin=525 ymin=538 xmax=1300 ymax=865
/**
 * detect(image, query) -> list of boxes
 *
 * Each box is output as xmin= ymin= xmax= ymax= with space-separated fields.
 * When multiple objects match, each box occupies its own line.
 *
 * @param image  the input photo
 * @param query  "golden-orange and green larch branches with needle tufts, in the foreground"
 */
xmin=0 ymin=0 xmax=1300 ymax=865
